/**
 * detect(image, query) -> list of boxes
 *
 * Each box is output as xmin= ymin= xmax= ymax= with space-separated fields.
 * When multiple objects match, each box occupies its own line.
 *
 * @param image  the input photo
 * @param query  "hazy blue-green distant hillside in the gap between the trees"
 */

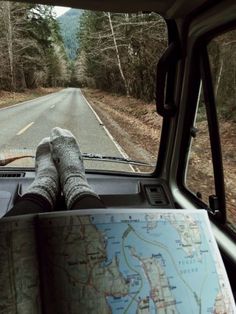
xmin=57 ymin=9 xmax=82 ymax=60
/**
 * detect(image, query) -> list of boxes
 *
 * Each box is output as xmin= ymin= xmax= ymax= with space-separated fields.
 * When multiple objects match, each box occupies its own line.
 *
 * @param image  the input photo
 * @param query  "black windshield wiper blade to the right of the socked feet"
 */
xmin=82 ymin=153 xmax=155 ymax=167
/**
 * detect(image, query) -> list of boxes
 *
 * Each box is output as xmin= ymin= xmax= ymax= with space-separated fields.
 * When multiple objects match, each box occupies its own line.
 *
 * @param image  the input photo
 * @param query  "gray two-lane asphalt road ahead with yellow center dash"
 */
xmin=0 ymin=88 xmax=131 ymax=171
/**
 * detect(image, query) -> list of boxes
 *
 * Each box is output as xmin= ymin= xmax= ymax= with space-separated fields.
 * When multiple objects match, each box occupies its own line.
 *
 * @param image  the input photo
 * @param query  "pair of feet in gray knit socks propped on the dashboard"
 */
xmin=26 ymin=127 xmax=99 ymax=209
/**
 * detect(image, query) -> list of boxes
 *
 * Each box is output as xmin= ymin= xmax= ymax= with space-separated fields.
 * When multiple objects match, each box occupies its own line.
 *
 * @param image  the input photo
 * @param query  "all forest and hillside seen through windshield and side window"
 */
xmin=0 ymin=1 xmax=236 ymax=114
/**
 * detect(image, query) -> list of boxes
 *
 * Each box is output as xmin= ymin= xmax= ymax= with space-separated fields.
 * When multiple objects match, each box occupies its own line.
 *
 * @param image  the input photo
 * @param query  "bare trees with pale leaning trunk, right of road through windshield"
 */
xmin=76 ymin=11 xmax=167 ymax=101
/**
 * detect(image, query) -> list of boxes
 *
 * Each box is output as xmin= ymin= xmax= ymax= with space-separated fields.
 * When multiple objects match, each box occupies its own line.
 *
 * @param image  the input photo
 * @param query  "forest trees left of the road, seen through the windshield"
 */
xmin=0 ymin=1 xmax=69 ymax=91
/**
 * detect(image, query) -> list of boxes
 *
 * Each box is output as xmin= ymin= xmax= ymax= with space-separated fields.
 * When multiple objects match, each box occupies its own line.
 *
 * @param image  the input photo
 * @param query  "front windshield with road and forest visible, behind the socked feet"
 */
xmin=0 ymin=1 xmax=167 ymax=172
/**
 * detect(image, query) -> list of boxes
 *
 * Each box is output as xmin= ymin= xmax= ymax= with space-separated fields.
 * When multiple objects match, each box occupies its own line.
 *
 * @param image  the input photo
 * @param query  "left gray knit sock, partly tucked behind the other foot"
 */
xmin=26 ymin=137 xmax=59 ymax=208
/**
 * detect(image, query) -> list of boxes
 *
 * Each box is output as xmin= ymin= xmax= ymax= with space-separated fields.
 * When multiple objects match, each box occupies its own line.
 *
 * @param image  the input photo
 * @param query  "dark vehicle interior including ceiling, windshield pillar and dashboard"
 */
xmin=0 ymin=0 xmax=236 ymax=296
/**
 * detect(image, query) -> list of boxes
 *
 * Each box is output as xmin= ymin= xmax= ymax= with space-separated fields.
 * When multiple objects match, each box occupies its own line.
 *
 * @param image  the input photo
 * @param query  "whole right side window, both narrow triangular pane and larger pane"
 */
xmin=186 ymin=30 xmax=236 ymax=233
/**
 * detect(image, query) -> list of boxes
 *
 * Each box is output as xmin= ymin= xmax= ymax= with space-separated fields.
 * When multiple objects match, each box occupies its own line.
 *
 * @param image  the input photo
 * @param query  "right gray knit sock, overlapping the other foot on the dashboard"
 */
xmin=50 ymin=127 xmax=99 ymax=209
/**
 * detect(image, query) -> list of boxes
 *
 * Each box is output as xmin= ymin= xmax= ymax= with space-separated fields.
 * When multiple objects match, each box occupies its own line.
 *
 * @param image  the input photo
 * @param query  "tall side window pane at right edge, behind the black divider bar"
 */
xmin=208 ymin=30 xmax=236 ymax=233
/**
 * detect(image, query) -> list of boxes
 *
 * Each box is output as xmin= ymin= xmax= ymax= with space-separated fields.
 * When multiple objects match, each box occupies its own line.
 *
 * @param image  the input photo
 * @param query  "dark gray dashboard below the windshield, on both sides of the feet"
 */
xmin=0 ymin=170 xmax=174 ymax=216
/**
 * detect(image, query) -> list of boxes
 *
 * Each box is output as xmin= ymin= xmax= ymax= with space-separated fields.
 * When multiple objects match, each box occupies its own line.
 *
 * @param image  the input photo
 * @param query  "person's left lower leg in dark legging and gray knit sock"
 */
xmin=5 ymin=138 xmax=59 ymax=216
